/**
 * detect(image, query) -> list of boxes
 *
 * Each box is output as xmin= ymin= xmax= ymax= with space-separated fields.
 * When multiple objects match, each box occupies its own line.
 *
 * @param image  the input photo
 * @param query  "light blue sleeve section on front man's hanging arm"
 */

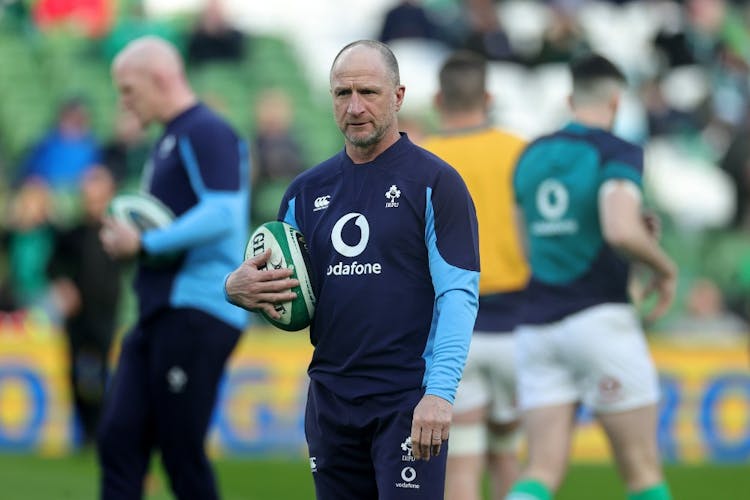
xmin=424 ymin=188 xmax=479 ymax=403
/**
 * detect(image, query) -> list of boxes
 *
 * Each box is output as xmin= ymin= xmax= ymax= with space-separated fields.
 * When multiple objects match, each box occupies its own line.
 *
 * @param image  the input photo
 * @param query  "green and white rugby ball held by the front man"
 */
xmin=245 ymin=221 xmax=315 ymax=332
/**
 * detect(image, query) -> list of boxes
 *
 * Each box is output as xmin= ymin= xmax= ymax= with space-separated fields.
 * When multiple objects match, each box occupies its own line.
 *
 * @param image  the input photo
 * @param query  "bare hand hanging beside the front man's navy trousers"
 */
xmin=411 ymin=394 xmax=452 ymax=460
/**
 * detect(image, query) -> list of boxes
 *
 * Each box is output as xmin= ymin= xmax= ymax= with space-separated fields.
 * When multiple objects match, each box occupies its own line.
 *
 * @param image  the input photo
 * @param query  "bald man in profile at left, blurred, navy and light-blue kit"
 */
xmin=98 ymin=36 xmax=249 ymax=500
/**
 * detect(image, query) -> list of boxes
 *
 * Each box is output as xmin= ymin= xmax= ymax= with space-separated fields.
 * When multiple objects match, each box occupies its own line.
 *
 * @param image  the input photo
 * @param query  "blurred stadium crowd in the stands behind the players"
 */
xmin=0 ymin=0 xmax=750 ymax=340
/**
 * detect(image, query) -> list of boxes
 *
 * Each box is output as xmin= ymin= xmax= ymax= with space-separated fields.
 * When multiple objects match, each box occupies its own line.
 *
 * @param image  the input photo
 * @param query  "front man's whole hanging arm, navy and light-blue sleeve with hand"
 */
xmin=411 ymin=171 xmax=479 ymax=460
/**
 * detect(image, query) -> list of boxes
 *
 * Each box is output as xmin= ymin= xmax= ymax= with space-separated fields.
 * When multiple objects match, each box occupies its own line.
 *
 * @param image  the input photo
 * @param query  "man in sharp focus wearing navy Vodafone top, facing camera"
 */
xmin=226 ymin=40 xmax=479 ymax=500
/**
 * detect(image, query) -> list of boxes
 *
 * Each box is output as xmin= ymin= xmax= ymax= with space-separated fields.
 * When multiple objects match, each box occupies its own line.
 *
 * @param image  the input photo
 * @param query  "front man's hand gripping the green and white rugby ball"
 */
xmin=224 ymin=249 xmax=299 ymax=319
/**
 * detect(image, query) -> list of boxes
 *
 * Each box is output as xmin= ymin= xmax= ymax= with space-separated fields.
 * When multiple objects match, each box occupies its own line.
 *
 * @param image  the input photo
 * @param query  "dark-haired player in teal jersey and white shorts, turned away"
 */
xmin=507 ymin=54 xmax=677 ymax=500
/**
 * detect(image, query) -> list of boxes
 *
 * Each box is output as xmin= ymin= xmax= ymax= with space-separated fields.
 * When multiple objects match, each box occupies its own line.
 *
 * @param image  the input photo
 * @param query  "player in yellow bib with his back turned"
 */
xmin=422 ymin=51 xmax=529 ymax=500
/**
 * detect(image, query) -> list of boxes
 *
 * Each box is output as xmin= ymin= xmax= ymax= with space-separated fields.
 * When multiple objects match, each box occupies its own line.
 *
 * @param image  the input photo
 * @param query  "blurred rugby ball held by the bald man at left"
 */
xmin=107 ymin=192 xmax=181 ymax=265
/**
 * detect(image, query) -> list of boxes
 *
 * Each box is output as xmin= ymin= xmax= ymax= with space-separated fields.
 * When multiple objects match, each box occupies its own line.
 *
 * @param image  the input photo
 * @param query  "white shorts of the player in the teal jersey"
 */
xmin=516 ymin=304 xmax=659 ymax=413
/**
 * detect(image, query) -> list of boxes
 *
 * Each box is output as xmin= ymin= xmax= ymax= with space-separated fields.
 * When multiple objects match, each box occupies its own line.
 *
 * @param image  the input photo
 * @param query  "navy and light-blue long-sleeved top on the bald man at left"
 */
xmin=135 ymin=104 xmax=250 ymax=328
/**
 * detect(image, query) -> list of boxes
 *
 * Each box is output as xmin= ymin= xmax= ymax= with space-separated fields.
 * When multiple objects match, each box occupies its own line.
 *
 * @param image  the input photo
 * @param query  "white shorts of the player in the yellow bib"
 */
xmin=453 ymin=331 xmax=518 ymax=423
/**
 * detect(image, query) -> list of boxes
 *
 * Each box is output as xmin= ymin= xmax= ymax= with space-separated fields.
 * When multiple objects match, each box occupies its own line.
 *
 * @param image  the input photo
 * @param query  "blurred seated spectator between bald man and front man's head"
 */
xmin=250 ymin=88 xmax=307 ymax=224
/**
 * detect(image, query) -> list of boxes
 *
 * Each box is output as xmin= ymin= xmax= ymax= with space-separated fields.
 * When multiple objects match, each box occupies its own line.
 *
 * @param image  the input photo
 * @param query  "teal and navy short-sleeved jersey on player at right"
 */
xmin=514 ymin=122 xmax=643 ymax=324
